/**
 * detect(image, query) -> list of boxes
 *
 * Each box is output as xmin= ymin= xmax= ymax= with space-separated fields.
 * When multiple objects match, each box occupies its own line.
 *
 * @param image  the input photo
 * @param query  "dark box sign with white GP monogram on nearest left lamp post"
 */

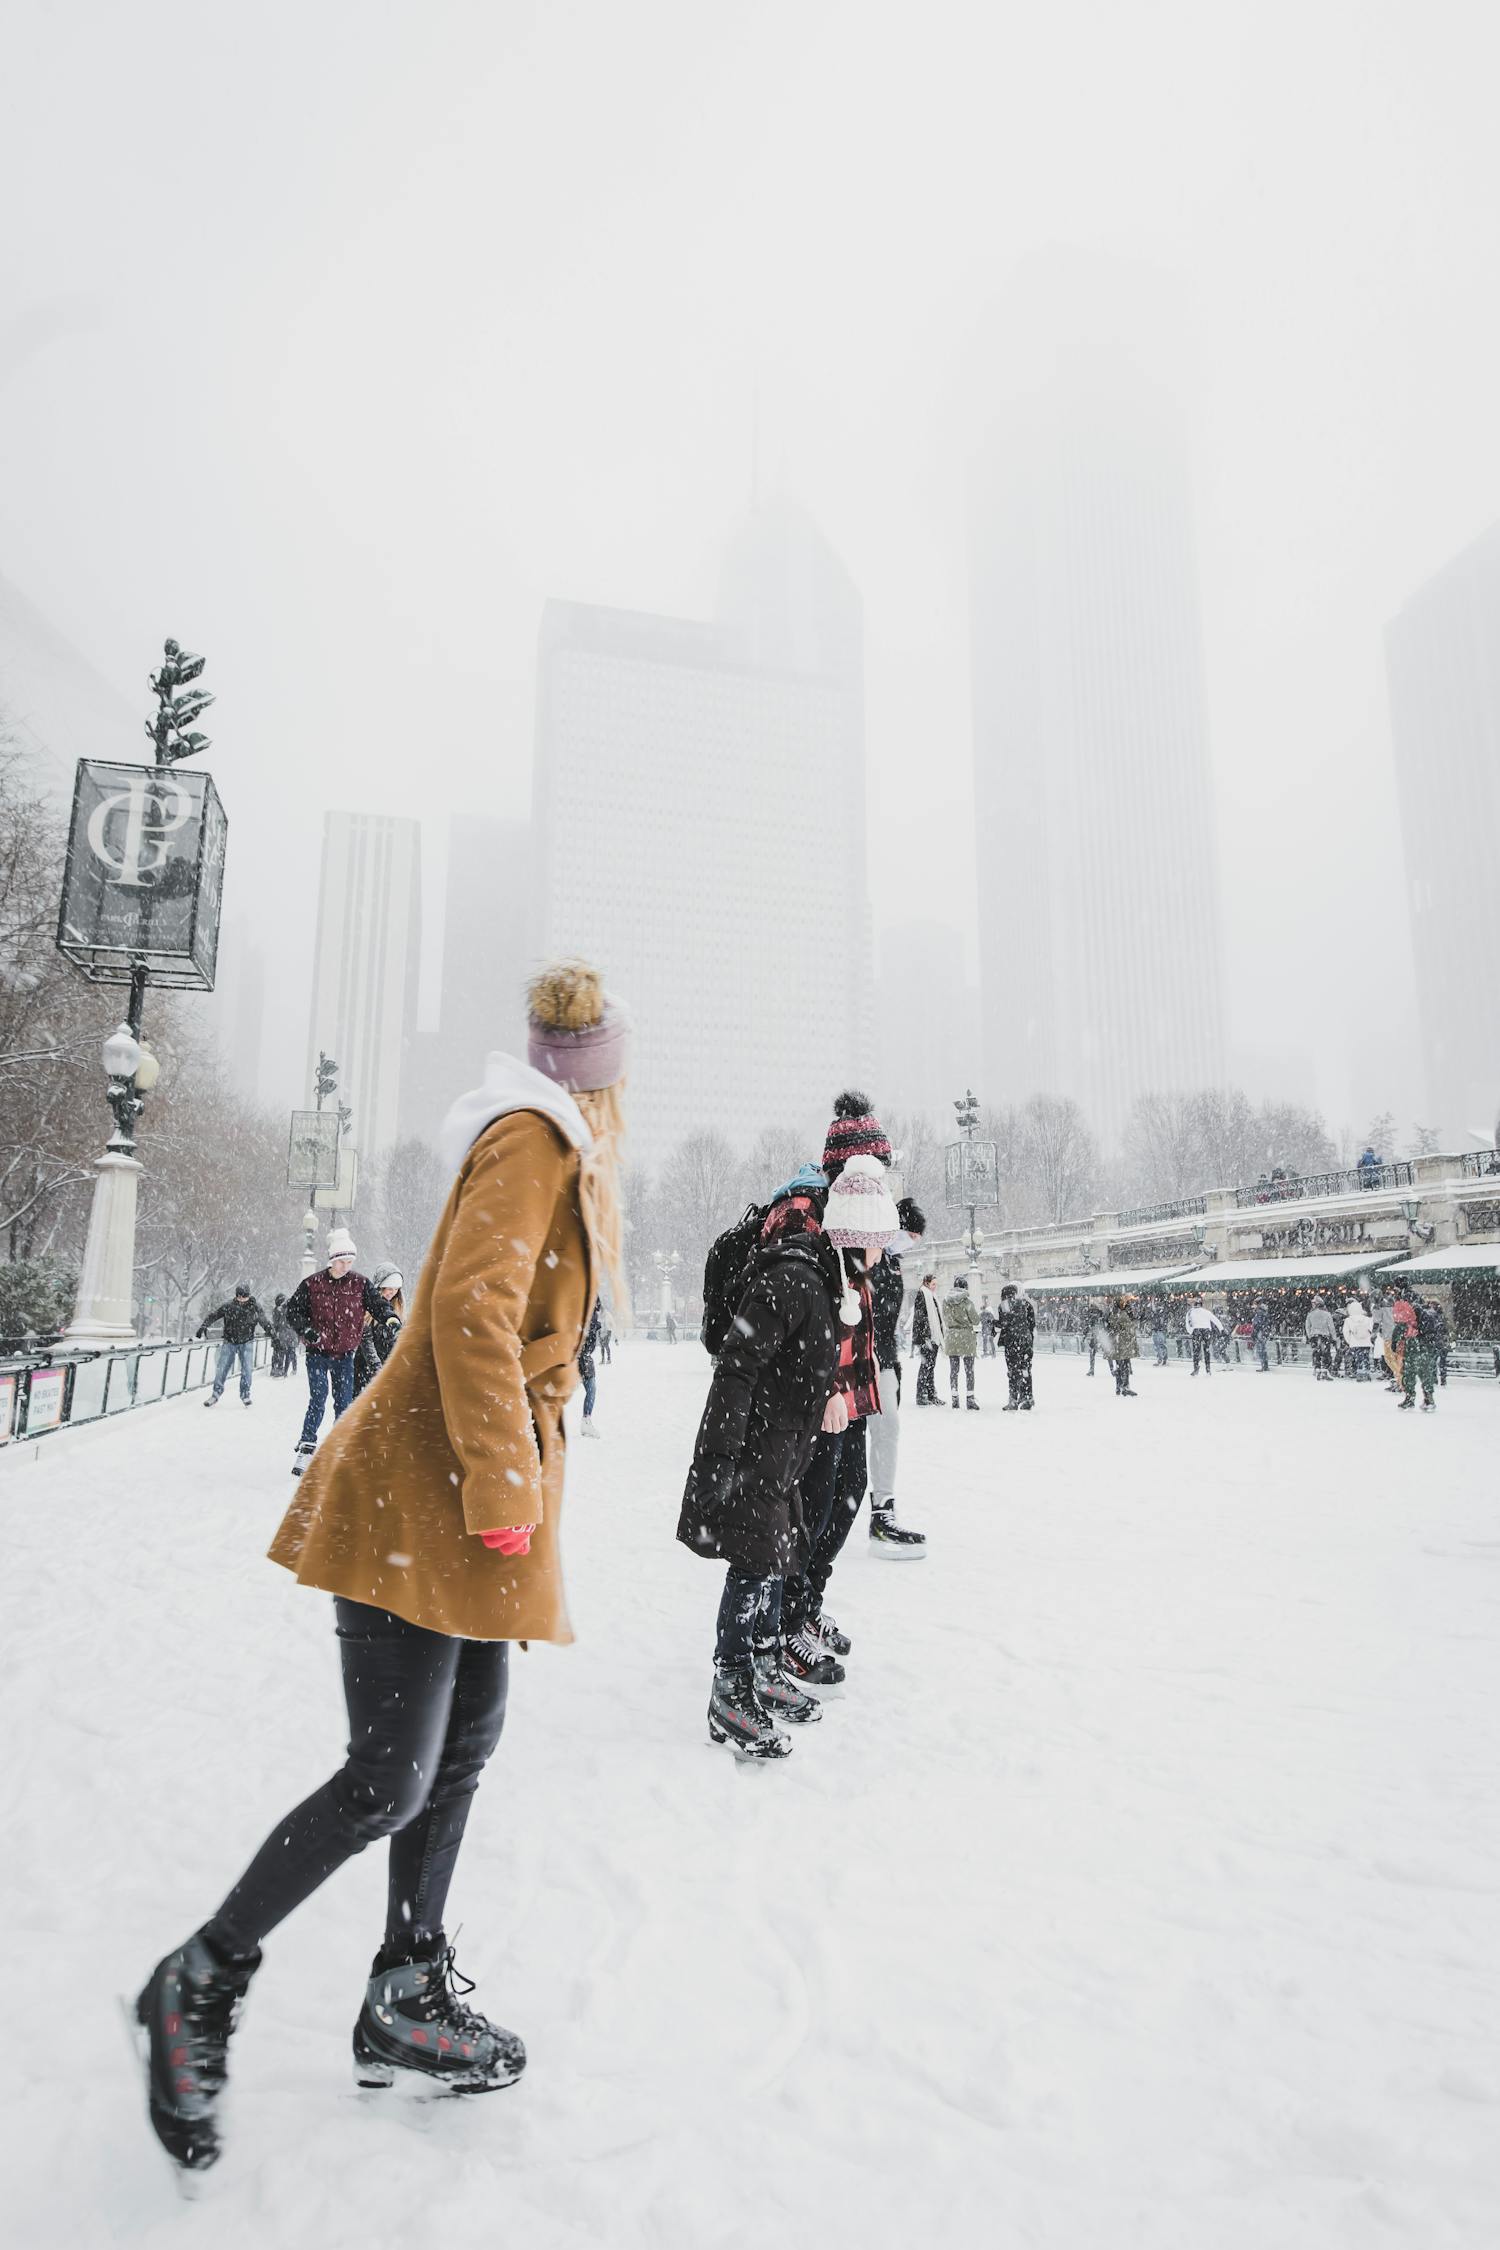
xmin=56 ymin=758 xmax=229 ymax=992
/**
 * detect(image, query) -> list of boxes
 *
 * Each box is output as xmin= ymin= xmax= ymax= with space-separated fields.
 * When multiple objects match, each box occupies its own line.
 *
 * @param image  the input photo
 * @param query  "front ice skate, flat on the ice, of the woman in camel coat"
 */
xmin=353 ymin=1946 xmax=526 ymax=2095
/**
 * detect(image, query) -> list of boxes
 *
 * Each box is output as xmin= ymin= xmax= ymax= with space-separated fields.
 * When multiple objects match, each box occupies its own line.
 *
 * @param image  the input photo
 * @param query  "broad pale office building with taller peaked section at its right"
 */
xmin=531 ymin=504 xmax=870 ymax=1168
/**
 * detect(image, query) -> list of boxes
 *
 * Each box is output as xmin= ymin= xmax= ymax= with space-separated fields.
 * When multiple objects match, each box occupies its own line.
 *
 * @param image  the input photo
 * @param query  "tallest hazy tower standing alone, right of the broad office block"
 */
xmin=969 ymin=259 xmax=1223 ymax=1145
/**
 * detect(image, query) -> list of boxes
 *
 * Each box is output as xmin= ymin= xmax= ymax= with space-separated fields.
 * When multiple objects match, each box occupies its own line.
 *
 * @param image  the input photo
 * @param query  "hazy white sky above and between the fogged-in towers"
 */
xmin=0 ymin=0 xmax=1500 ymax=1123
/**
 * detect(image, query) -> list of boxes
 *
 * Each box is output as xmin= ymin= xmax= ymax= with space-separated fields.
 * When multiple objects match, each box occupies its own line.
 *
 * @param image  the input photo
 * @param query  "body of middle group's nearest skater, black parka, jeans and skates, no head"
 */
xmin=677 ymin=1193 xmax=841 ymax=1757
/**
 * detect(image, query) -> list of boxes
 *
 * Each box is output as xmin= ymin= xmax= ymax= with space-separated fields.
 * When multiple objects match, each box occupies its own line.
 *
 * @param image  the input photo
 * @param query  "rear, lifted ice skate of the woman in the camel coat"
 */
xmin=135 ymin=1935 xmax=261 ymax=2171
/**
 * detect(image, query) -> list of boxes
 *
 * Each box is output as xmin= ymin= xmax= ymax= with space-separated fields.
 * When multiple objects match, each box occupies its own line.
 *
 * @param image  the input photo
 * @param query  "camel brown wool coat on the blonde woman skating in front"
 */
xmin=270 ymin=1109 xmax=594 ymax=1640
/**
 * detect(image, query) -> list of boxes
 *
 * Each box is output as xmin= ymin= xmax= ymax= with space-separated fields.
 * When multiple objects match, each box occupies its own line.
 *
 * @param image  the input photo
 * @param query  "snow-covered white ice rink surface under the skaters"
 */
xmin=0 ymin=1343 xmax=1500 ymax=2250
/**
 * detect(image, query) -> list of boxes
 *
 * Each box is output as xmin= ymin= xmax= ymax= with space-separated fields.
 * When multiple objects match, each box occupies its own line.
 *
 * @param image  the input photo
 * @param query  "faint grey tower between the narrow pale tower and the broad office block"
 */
xmin=400 ymin=815 xmax=531 ymax=1145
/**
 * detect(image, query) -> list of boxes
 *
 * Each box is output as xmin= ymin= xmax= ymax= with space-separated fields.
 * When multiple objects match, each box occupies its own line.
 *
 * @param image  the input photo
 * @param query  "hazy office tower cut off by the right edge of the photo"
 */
xmin=1385 ymin=524 xmax=1500 ymax=1141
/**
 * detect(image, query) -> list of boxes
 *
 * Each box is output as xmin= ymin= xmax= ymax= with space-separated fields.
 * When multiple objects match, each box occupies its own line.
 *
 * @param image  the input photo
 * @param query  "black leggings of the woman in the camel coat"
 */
xmin=205 ymin=1600 xmax=510 ymax=1960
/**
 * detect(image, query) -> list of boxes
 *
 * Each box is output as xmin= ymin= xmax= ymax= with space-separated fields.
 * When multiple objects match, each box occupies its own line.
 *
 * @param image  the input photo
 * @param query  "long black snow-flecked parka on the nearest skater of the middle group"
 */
xmin=677 ymin=1235 xmax=839 ymax=1577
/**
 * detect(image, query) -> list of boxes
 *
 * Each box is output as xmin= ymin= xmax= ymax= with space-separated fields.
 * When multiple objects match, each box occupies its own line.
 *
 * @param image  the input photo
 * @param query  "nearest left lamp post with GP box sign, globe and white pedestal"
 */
xmin=56 ymin=641 xmax=229 ymax=1343
